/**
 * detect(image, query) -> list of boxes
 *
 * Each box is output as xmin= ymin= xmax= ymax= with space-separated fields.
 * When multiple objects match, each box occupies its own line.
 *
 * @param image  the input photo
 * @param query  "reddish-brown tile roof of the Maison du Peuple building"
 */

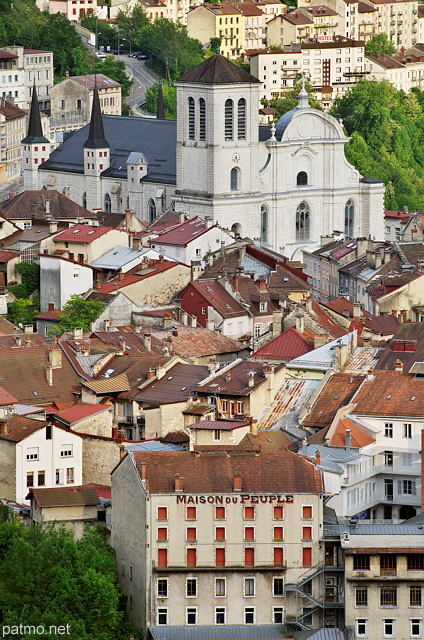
xmin=129 ymin=451 xmax=323 ymax=492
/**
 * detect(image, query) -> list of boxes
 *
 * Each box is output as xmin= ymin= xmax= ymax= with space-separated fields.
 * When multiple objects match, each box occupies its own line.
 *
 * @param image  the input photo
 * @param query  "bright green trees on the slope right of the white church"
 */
xmin=332 ymin=80 xmax=424 ymax=210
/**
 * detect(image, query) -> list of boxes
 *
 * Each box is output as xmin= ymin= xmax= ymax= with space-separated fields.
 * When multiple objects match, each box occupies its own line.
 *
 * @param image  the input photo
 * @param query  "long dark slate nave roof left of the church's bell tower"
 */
xmin=39 ymin=116 xmax=177 ymax=184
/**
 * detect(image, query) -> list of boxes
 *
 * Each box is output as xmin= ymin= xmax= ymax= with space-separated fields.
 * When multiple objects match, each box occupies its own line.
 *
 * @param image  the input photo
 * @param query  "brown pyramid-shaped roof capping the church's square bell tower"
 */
xmin=176 ymin=54 xmax=261 ymax=84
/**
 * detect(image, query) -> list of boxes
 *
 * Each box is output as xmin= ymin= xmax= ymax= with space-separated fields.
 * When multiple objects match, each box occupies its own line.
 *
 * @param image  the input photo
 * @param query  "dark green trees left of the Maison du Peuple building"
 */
xmin=0 ymin=521 xmax=137 ymax=640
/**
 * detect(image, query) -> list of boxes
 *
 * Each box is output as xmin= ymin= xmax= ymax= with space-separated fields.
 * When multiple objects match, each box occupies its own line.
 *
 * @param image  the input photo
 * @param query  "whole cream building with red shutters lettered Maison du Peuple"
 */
xmin=112 ymin=447 xmax=322 ymax=630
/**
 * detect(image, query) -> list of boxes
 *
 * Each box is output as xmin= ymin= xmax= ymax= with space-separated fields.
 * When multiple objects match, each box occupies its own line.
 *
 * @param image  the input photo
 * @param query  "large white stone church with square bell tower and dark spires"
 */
xmin=23 ymin=55 xmax=384 ymax=260
